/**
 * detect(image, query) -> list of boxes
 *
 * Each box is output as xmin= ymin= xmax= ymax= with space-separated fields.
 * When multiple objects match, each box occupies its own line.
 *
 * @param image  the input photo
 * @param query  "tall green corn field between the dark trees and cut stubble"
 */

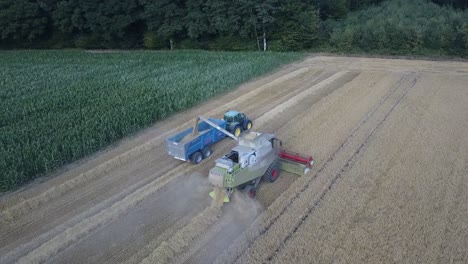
xmin=0 ymin=51 xmax=303 ymax=191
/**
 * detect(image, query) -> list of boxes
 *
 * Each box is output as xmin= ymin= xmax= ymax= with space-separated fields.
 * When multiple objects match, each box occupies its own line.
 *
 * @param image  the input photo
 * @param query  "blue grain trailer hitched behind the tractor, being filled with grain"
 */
xmin=166 ymin=118 xmax=226 ymax=164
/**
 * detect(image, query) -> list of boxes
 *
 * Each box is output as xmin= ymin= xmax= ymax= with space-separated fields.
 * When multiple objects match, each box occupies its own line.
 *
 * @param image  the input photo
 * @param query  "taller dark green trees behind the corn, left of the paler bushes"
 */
xmin=0 ymin=0 xmax=380 ymax=50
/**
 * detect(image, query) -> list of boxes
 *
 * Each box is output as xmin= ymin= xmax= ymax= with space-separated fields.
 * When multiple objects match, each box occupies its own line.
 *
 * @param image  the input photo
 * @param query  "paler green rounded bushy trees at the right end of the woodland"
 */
xmin=324 ymin=0 xmax=468 ymax=56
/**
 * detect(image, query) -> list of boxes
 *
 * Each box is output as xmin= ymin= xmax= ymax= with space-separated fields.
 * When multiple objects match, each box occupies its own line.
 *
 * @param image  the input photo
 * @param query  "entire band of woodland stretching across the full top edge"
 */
xmin=0 ymin=0 xmax=468 ymax=52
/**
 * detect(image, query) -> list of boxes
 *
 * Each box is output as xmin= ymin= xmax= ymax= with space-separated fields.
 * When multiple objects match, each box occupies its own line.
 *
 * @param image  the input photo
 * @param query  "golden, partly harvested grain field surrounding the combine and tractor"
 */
xmin=0 ymin=54 xmax=468 ymax=263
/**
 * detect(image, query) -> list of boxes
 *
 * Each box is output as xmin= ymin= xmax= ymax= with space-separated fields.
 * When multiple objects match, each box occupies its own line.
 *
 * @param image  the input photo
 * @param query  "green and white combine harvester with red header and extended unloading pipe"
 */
xmin=199 ymin=116 xmax=314 ymax=202
